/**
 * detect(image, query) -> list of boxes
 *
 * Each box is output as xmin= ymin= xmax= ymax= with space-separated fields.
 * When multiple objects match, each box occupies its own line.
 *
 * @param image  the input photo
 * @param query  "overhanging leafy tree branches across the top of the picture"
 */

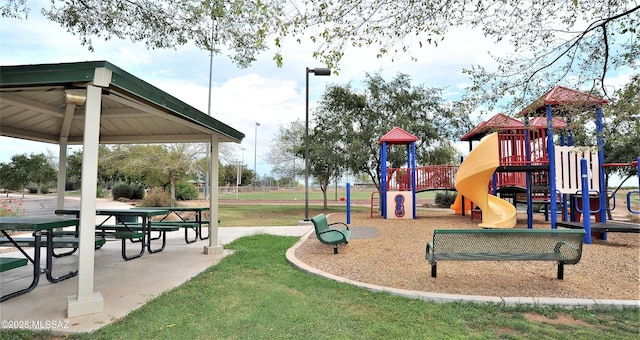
xmin=0 ymin=0 xmax=640 ymax=107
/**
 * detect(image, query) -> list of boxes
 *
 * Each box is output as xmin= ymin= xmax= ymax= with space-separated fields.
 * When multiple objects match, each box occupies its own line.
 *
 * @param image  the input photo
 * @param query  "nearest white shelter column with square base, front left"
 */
xmin=67 ymin=83 xmax=104 ymax=318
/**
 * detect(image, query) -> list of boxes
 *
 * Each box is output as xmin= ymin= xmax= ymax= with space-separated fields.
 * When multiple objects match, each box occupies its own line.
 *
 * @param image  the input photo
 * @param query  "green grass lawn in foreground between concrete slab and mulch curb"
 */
xmin=0 ymin=235 xmax=640 ymax=339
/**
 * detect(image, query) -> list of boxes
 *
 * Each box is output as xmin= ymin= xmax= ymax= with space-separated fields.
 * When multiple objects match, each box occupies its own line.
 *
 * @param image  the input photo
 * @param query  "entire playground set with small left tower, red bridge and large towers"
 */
xmin=372 ymin=86 xmax=640 ymax=238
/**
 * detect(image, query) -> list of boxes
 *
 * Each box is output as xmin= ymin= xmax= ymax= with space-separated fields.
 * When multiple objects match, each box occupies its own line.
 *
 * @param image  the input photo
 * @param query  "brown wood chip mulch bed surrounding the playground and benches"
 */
xmin=295 ymin=210 xmax=640 ymax=300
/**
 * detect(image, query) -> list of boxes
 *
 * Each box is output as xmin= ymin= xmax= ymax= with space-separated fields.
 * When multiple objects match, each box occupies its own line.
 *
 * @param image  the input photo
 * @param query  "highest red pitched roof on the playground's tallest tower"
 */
xmin=518 ymin=86 xmax=607 ymax=116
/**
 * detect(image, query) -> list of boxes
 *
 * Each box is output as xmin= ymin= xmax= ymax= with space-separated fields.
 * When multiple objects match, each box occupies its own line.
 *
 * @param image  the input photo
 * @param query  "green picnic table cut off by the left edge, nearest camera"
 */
xmin=0 ymin=216 xmax=79 ymax=302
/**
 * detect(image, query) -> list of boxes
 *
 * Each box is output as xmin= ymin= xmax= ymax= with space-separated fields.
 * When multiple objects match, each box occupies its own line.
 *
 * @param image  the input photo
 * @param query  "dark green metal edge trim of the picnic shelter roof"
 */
xmin=0 ymin=61 xmax=245 ymax=143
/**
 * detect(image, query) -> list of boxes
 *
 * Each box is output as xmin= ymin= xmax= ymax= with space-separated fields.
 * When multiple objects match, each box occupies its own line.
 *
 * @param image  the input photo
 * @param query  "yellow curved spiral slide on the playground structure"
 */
xmin=456 ymin=133 xmax=516 ymax=228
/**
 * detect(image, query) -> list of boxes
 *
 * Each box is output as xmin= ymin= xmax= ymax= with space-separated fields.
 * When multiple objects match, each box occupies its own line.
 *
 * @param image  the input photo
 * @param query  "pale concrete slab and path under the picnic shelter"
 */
xmin=0 ymin=199 xmax=312 ymax=335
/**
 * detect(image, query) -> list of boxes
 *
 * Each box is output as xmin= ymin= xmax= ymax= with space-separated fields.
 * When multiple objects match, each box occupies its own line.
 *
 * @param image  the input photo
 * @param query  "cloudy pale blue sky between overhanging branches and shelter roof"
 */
xmin=0 ymin=2 xmax=628 ymax=185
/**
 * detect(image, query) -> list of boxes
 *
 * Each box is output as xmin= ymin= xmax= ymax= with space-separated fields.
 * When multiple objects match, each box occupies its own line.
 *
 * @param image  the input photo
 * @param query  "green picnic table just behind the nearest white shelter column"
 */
xmin=55 ymin=208 xmax=169 ymax=260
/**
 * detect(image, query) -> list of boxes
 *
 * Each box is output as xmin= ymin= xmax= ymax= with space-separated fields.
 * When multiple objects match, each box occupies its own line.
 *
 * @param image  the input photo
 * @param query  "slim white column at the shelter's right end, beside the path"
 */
xmin=204 ymin=135 xmax=224 ymax=255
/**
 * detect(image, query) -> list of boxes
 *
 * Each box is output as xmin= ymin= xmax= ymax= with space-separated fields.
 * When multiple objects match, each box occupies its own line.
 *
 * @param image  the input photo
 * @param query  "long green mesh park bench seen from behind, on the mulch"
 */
xmin=426 ymin=229 xmax=585 ymax=280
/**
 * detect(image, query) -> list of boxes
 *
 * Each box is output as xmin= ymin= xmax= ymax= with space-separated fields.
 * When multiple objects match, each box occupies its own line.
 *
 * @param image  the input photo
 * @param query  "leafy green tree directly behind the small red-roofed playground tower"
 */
xmin=315 ymin=74 xmax=471 ymax=188
